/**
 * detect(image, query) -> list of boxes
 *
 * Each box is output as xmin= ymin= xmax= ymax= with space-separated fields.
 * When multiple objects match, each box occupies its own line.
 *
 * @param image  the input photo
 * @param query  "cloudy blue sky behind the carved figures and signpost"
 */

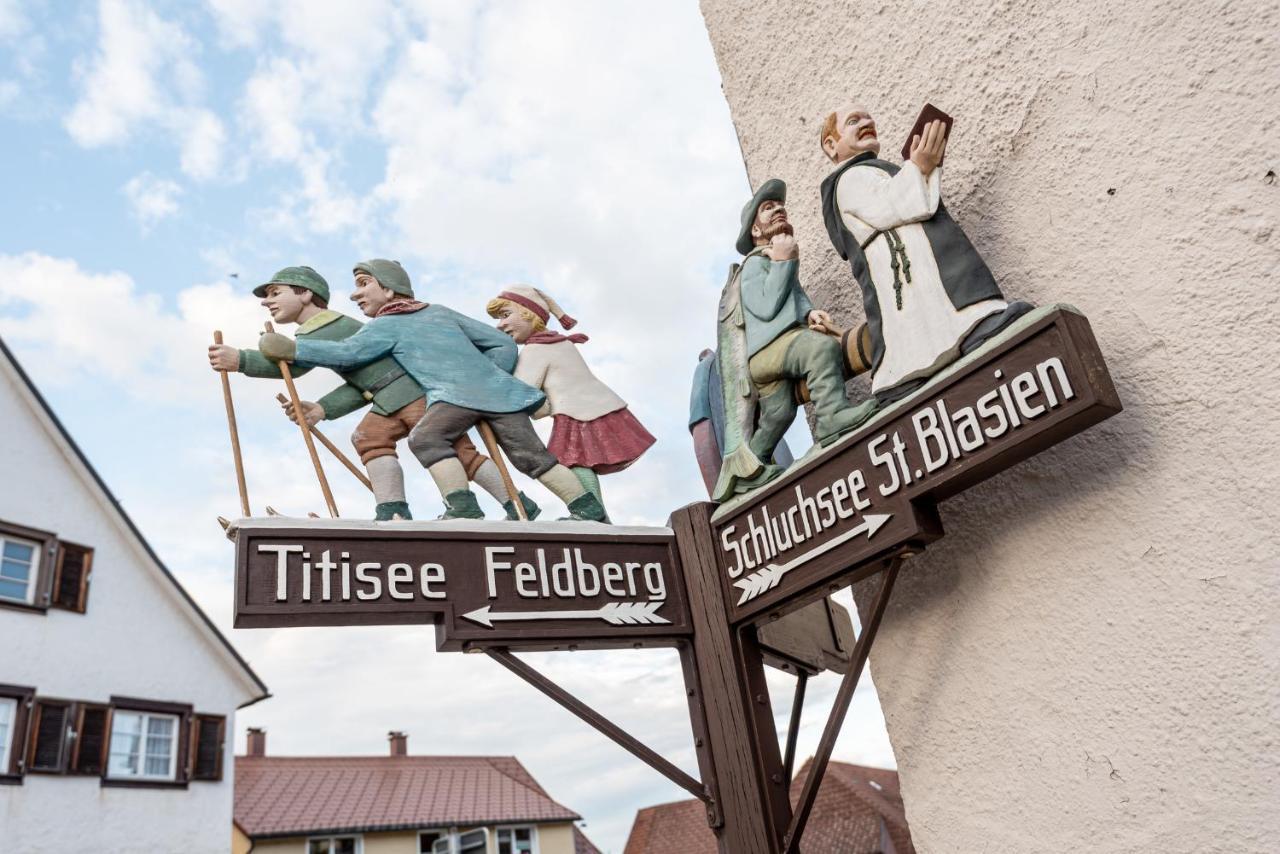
xmin=0 ymin=0 xmax=893 ymax=851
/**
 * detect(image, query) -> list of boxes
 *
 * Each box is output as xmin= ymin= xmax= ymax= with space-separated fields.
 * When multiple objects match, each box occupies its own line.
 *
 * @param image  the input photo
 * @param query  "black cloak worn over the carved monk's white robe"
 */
xmin=822 ymin=151 xmax=1004 ymax=374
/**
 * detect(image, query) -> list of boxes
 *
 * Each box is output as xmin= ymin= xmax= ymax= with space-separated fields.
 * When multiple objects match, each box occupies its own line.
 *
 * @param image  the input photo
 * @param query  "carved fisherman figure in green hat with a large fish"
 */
xmin=714 ymin=178 xmax=876 ymax=501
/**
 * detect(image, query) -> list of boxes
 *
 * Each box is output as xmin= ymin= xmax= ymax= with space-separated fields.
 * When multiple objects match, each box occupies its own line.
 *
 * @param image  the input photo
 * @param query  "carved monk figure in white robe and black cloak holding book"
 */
xmin=820 ymin=106 xmax=1030 ymax=405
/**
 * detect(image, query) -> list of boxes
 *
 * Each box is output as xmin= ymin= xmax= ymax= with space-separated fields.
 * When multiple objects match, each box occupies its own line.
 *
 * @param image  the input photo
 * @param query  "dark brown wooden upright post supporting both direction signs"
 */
xmin=671 ymin=502 xmax=791 ymax=854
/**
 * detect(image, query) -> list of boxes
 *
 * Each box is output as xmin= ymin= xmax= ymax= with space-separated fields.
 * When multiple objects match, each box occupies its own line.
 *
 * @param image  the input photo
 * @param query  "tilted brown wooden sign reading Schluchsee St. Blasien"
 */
xmin=712 ymin=307 xmax=1120 ymax=624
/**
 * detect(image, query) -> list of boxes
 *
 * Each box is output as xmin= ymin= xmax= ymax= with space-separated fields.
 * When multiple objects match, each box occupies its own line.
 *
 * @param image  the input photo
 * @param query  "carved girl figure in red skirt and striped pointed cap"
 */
xmin=485 ymin=284 xmax=654 ymax=522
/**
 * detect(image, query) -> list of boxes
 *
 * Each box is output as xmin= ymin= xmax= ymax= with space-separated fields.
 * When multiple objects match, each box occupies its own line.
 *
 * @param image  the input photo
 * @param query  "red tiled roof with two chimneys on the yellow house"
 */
xmin=234 ymin=757 xmax=581 ymax=851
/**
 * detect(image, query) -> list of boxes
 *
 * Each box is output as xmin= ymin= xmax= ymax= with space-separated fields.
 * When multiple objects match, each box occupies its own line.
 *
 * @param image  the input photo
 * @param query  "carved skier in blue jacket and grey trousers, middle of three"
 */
xmin=259 ymin=260 xmax=604 ymax=521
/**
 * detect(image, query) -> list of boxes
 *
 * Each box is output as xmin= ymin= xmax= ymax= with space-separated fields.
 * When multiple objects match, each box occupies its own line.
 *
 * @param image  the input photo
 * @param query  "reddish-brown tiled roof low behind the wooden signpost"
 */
xmin=623 ymin=762 xmax=915 ymax=854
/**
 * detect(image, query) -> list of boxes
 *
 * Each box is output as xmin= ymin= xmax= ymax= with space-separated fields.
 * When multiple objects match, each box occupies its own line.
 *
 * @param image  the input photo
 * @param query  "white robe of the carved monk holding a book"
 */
xmin=836 ymin=160 xmax=1009 ymax=393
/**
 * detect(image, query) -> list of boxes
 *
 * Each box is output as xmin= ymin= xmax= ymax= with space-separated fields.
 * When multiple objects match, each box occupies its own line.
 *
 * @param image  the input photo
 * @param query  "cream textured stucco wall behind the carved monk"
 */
xmin=701 ymin=0 xmax=1280 ymax=853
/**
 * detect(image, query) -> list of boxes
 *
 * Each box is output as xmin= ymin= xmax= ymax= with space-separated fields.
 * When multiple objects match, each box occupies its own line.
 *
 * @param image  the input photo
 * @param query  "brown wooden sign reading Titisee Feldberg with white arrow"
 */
xmin=234 ymin=517 xmax=691 ymax=650
